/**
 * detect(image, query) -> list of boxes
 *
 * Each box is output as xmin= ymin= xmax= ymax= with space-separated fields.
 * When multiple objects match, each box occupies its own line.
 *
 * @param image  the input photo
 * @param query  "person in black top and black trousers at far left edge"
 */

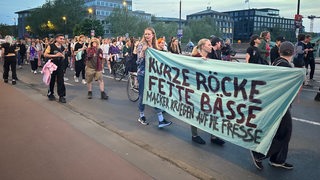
xmin=1 ymin=36 xmax=19 ymax=85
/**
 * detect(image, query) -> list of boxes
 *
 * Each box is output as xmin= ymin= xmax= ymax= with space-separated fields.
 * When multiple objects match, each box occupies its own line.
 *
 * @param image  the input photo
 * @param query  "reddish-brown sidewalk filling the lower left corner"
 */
xmin=0 ymin=81 xmax=152 ymax=180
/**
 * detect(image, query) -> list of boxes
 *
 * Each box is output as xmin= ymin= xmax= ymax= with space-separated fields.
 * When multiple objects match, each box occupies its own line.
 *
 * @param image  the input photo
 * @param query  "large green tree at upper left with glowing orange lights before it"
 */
xmin=27 ymin=0 xmax=87 ymax=37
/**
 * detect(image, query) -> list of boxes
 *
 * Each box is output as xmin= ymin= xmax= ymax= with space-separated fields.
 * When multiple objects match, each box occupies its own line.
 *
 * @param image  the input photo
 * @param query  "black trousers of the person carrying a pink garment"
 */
xmin=48 ymin=60 xmax=66 ymax=97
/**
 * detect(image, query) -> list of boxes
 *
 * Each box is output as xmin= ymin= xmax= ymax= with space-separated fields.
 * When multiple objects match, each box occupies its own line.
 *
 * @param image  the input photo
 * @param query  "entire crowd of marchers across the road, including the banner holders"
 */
xmin=1 ymin=27 xmax=320 ymax=170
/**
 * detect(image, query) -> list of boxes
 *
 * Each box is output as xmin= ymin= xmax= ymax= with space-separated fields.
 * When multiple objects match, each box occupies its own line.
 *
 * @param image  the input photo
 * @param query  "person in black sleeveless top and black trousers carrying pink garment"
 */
xmin=44 ymin=34 xmax=66 ymax=103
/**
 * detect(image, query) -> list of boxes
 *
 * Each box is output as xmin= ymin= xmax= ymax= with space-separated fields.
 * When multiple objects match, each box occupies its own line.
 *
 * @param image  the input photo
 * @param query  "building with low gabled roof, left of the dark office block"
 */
xmin=187 ymin=7 xmax=233 ymax=39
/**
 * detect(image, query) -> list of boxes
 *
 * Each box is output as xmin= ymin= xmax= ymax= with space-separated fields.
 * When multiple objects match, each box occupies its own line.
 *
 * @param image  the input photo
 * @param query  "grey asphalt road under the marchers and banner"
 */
xmin=1 ymin=60 xmax=320 ymax=179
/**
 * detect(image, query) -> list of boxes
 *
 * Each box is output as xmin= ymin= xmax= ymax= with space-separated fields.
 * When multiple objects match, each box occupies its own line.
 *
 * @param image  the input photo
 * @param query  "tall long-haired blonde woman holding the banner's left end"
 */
xmin=137 ymin=27 xmax=172 ymax=128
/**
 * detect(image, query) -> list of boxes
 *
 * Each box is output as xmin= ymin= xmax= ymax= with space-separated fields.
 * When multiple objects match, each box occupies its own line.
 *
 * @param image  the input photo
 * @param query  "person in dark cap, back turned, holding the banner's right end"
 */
xmin=250 ymin=41 xmax=294 ymax=170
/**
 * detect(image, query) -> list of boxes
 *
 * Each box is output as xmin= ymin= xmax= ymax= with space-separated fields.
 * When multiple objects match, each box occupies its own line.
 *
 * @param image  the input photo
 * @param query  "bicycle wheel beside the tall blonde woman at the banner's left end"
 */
xmin=127 ymin=72 xmax=139 ymax=102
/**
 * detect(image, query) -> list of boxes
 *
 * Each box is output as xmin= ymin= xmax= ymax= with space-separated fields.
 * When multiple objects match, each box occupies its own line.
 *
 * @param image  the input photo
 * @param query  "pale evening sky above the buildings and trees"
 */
xmin=0 ymin=0 xmax=320 ymax=33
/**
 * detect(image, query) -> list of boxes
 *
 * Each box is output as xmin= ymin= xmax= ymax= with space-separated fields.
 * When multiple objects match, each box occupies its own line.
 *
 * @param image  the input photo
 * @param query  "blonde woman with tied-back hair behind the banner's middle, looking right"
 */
xmin=191 ymin=39 xmax=225 ymax=145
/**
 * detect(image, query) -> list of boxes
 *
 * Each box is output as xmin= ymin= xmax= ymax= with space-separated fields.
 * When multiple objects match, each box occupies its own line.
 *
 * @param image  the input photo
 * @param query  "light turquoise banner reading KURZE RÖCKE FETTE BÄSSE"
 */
xmin=143 ymin=48 xmax=305 ymax=154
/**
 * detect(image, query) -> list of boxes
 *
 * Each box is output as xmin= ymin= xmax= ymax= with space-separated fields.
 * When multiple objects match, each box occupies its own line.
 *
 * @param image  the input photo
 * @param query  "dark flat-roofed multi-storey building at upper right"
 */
xmin=224 ymin=8 xmax=295 ymax=41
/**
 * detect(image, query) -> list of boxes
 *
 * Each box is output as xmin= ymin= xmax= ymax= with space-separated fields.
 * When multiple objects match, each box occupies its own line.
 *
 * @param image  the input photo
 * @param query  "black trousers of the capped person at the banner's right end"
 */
xmin=252 ymin=110 xmax=292 ymax=164
